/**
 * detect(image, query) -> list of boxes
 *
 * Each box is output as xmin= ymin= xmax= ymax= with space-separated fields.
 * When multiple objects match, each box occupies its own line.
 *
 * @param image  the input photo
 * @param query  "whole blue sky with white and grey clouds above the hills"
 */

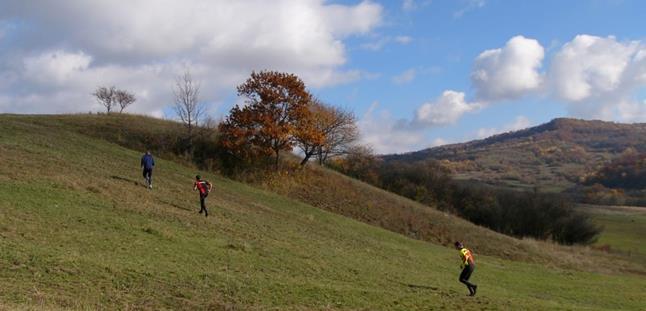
xmin=0 ymin=0 xmax=646 ymax=153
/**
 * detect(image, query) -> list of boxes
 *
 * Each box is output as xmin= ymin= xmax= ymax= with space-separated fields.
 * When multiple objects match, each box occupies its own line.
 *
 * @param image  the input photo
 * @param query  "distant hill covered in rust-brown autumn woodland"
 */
xmin=384 ymin=118 xmax=646 ymax=191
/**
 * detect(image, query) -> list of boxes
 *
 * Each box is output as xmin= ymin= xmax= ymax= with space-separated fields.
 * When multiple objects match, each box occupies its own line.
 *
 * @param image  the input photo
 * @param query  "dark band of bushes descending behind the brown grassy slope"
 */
xmin=333 ymin=153 xmax=600 ymax=244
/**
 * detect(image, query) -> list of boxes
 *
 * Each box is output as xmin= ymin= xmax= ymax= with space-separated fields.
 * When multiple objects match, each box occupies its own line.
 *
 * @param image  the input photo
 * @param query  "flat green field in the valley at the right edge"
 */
xmin=585 ymin=206 xmax=646 ymax=260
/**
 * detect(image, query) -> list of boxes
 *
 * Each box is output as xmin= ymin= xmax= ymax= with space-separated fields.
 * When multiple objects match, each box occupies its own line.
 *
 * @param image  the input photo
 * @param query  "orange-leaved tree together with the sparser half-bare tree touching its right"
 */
xmin=219 ymin=71 xmax=359 ymax=168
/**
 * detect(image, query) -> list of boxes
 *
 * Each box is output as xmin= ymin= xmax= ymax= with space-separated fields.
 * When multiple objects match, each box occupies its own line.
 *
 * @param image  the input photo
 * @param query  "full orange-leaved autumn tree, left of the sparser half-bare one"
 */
xmin=219 ymin=71 xmax=316 ymax=168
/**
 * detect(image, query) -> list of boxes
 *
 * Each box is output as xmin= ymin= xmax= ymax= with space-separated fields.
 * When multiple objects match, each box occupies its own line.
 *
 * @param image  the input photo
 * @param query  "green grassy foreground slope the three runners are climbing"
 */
xmin=0 ymin=116 xmax=646 ymax=310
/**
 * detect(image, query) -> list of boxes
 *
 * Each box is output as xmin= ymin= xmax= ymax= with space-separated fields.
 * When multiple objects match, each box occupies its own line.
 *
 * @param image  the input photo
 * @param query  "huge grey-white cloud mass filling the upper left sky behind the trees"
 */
xmin=0 ymin=0 xmax=383 ymax=113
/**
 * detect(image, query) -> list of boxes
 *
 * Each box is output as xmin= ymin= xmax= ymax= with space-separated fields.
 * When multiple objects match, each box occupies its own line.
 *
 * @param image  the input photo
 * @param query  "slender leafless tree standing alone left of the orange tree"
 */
xmin=173 ymin=69 xmax=206 ymax=142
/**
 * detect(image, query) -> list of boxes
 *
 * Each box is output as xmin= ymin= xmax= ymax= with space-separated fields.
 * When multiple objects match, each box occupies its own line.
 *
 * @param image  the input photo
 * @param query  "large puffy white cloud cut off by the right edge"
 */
xmin=549 ymin=35 xmax=646 ymax=121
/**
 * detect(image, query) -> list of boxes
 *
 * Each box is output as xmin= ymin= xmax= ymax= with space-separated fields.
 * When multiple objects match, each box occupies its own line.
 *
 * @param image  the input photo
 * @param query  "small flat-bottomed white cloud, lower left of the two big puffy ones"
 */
xmin=411 ymin=90 xmax=482 ymax=127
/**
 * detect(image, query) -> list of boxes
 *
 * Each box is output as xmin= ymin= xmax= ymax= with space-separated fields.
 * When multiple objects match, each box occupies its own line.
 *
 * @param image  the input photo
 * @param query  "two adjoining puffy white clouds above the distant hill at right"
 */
xmin=471 ymin=35 xmax=646 ymax=122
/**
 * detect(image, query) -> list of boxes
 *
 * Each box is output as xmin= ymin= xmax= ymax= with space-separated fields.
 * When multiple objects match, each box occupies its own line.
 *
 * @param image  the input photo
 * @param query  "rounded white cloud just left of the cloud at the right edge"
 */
xmin=471 ymin=36 xmax=544 ymax=101
